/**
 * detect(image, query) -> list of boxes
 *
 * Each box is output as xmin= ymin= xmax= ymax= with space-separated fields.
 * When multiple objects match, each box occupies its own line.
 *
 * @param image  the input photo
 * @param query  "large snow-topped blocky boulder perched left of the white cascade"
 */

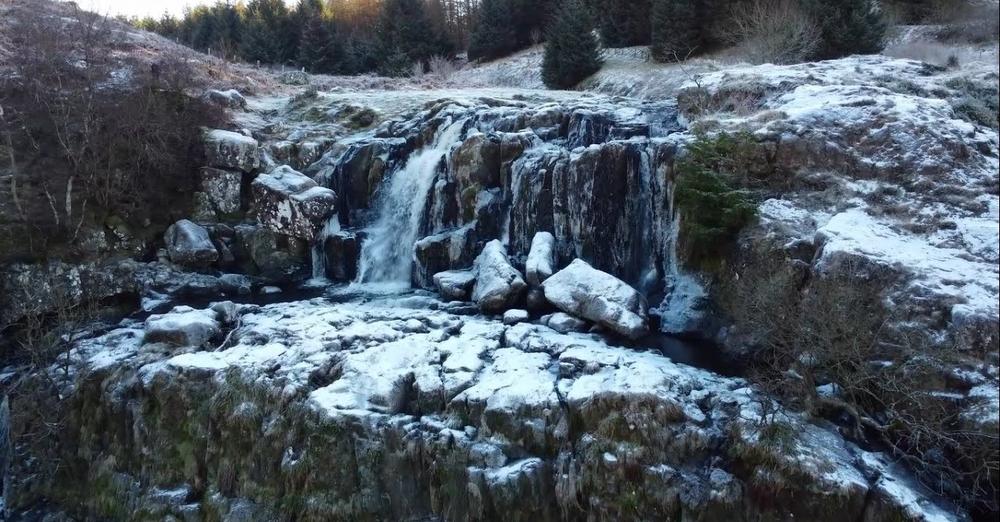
xmin=252 ymin=166 xmax=337 ymax=241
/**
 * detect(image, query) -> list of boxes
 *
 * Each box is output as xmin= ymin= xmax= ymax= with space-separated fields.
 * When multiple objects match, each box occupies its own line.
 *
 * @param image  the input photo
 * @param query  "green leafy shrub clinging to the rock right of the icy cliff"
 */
xmin=674 ymin=133 xmax=756 ymax=268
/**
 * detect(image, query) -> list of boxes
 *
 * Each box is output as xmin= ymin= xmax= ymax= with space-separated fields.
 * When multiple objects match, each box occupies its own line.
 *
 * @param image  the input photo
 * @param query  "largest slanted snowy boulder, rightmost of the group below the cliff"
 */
xmin=542 ymin=259 xmax=648 ymax=339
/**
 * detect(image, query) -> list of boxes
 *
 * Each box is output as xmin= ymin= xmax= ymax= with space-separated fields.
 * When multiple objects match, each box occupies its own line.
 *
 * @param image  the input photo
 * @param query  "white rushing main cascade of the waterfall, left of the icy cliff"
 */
xmin=357 ymin=120 xmax=465 ymax=285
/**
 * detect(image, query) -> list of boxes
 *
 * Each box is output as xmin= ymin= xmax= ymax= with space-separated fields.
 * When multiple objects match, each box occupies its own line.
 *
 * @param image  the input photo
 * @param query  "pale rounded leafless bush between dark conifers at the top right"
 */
xmin=725 ymin=0 xmax=820 ymax=64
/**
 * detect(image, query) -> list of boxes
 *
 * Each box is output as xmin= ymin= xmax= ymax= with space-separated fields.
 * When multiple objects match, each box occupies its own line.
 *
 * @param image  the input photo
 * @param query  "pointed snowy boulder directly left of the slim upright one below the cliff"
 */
xmin=472 ymin=239 xmax=528 ymax=313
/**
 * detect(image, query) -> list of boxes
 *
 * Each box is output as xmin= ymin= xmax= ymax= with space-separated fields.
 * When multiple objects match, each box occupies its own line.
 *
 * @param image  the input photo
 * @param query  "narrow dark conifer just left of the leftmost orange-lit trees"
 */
xmin=296 ymin=0 xmax=344 ymax=74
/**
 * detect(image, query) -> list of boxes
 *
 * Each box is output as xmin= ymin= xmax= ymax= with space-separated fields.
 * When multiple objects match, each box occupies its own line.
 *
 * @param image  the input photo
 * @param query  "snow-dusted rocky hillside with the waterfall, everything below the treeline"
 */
xmin=0 ymin=0 xmax=1000 ymax=522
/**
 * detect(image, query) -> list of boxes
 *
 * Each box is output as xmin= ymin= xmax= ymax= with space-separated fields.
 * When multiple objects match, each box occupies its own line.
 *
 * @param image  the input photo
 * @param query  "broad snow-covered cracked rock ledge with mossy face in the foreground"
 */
xmin=9 ymin=293 xmax=953 ymax=521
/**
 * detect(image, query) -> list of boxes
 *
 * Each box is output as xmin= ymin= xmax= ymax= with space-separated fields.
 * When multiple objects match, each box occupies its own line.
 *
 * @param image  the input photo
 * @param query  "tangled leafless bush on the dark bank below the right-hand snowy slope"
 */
xmin=723 ymin=254 xmax=1000 ymax=510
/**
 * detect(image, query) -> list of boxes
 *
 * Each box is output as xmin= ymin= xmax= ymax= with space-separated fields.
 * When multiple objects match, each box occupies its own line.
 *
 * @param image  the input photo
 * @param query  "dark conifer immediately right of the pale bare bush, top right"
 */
xmin=806 ymin=0 xmax=886 ymax=60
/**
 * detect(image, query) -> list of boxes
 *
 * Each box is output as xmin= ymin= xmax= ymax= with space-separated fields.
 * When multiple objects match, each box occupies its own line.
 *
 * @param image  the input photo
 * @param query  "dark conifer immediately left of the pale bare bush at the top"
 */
xmin=650 ymin=0 xmax=703 ymax=62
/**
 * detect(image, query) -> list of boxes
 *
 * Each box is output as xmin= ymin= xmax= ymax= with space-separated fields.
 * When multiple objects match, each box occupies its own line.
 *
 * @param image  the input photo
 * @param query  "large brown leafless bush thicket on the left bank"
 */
xmin=0 ymin=6 xmax=220 ymax=260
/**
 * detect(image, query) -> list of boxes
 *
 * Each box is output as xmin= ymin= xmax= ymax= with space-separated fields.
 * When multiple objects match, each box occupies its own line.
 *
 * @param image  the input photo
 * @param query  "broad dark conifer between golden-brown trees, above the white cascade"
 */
xmin=377 ymin=0 xmax=451 ymax=76
